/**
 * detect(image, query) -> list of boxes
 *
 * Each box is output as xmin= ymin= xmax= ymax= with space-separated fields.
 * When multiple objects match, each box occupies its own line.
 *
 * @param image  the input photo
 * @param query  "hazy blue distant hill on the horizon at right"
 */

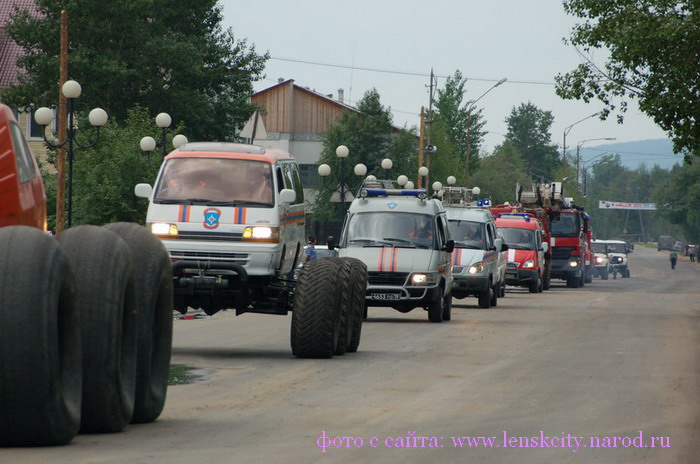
xmin=567 ymin=139 xmax=683 ymax=173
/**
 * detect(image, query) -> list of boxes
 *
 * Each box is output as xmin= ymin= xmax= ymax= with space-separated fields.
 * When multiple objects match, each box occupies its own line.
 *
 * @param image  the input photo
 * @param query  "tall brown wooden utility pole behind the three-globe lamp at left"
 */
xmin=56 ymin=10 xmax=68 ymax=234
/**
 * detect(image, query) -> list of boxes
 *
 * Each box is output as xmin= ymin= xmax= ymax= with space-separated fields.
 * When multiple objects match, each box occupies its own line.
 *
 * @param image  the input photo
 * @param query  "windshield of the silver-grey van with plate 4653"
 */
xmin=345 ymin=212 xmax=434 ymax=248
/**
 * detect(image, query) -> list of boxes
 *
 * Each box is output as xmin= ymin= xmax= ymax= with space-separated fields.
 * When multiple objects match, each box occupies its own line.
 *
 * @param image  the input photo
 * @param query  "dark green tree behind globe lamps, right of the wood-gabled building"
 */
xmin=313 ymin=89 xmax=418 ymax=222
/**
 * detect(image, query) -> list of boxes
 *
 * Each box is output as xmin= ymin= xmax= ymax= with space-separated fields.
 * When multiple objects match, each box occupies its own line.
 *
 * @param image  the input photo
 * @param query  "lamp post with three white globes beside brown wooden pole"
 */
xmin=34 ymin=80 xmax=108 ymax=231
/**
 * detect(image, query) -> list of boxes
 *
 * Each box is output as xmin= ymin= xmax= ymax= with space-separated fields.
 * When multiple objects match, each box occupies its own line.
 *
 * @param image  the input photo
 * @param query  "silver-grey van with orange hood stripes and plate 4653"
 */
xmin=337 ymin=180 xmax=454 ymax=322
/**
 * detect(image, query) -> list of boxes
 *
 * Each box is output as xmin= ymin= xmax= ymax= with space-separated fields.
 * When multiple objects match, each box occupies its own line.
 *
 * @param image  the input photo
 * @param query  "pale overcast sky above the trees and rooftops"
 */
xmin=220 ymin=0 xmax=667 ymax=161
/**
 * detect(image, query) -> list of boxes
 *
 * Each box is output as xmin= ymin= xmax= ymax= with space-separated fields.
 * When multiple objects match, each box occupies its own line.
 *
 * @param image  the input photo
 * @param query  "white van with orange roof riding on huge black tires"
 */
xmin=135 ymin=142 xmax=366 ymax=357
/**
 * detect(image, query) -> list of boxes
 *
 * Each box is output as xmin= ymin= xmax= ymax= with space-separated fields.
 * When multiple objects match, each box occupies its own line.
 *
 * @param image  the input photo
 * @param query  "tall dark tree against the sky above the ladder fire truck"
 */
xmin=506 ymin=102 xmax=561 ymax=181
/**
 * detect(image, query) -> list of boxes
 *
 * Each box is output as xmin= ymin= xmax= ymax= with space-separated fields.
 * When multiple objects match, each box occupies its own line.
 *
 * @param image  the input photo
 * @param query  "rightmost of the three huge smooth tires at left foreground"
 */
xmin=105 ymin=222 xmax=174 ymax=423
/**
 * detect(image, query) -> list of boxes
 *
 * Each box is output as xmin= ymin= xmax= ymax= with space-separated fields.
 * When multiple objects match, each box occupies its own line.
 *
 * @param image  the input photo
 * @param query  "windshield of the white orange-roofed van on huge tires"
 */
xmin=153 ymin=158 xmax=274 ymax=207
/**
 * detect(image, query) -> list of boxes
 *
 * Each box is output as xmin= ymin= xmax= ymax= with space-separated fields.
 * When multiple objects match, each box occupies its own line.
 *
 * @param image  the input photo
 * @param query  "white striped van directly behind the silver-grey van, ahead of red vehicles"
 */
xmin=442 ymin=187 xmax=508 ymax=308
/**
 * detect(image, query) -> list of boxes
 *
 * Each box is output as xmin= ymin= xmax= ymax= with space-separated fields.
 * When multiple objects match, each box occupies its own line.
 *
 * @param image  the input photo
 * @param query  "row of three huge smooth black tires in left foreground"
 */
xmin=0 ymin=223 xmax=173 ymax=446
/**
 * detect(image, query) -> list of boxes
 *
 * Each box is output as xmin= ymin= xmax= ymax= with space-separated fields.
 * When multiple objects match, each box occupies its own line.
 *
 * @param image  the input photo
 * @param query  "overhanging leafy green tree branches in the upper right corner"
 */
xmin=556 ymin=0 xmax=700 ymax=160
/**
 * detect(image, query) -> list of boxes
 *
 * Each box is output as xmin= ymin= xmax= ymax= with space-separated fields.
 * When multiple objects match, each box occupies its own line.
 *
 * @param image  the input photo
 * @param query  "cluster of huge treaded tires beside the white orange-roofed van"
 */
xmin=290 ymin=258 xmax=367 ymax=358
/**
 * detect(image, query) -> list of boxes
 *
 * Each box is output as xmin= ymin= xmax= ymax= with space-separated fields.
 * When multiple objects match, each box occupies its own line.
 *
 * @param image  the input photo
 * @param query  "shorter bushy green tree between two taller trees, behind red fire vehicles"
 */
xmin=471 ymin=140 xmax=532 ymax=204
